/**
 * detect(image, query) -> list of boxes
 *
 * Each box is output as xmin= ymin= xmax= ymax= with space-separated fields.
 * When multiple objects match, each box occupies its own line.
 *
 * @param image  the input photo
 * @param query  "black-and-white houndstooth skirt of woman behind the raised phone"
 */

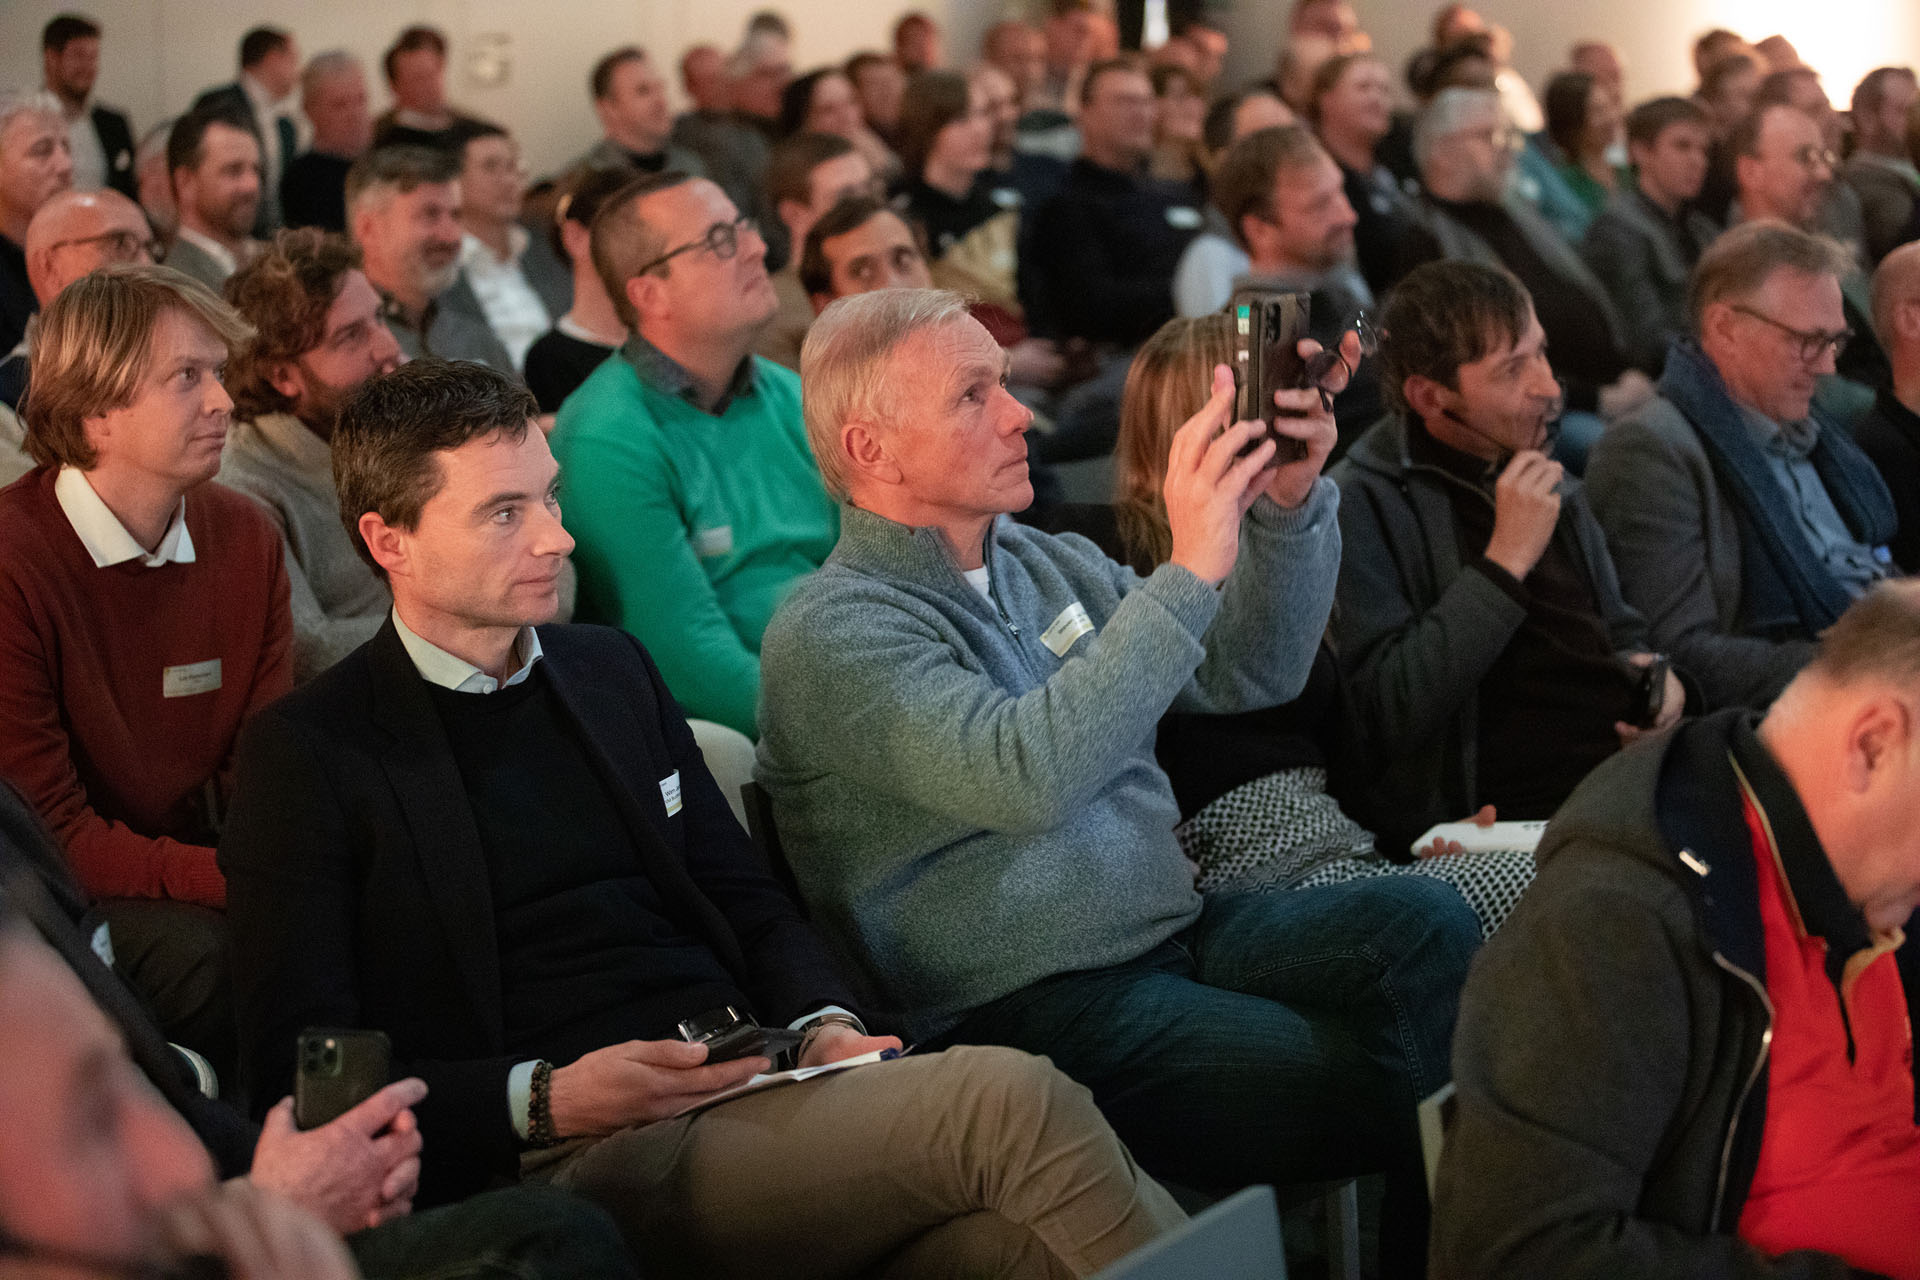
xmin=1173 ymin=768 xmax=1534 ymax=936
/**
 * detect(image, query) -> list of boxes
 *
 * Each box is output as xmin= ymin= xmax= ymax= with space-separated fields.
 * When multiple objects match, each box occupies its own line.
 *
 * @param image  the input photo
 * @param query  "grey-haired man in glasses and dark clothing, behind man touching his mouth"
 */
xmin=1407 ymin=88 xmax=1653 ymax=458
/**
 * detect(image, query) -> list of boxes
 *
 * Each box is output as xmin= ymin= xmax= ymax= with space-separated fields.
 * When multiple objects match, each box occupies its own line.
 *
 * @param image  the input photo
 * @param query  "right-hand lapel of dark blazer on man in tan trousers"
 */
xmin=540 ymin=628 xmax=749 ymax=986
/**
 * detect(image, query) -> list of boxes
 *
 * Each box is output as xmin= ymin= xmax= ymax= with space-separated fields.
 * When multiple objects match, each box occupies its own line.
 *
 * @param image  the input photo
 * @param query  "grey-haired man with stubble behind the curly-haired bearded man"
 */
xmin=348 ymin=146 xmax=516 ymax=376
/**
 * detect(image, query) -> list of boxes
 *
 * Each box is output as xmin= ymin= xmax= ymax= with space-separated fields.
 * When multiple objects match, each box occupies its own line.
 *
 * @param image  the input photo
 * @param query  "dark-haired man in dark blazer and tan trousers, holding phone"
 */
xmin=221 ymin=359 xmax=1181 ymax=1276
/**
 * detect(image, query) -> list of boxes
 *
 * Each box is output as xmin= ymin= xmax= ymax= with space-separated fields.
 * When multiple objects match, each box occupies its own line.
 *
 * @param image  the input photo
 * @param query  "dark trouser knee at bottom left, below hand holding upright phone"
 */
xmin=348 ymin=1186 xmax=639 ymax=1280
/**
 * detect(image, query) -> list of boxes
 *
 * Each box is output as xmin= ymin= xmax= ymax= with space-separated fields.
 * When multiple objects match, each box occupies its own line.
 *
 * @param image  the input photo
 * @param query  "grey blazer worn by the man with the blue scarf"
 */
xmin=1586 ymin=397 xmax=1814 ymax=706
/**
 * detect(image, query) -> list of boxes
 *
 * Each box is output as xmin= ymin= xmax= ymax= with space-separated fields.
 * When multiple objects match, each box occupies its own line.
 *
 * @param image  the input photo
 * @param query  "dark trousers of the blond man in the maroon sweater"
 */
xmin=100 ymin=898 xmax=240 ymax=1098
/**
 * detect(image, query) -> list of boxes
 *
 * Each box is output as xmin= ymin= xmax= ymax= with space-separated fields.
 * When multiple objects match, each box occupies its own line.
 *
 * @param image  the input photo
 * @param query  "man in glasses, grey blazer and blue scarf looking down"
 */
xmin=1588 ymin=225 xmax=1895 ymax=706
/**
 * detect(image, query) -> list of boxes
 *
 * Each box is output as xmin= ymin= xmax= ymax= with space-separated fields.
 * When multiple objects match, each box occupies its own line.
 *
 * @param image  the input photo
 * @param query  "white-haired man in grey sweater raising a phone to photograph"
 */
xmin=756 ymin=290 xmax=1478 ymax=1274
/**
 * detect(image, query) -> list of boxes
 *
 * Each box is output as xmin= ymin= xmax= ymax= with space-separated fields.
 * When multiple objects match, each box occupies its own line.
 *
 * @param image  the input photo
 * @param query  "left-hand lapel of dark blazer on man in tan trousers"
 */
xmin=367 ymin=618 xmax=505 ymax=1044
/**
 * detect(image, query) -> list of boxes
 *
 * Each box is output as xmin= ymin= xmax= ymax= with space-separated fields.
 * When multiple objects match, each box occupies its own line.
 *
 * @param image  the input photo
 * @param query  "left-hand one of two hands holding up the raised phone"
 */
xmin=1162 ymin=365 xmax=1282 ymax=587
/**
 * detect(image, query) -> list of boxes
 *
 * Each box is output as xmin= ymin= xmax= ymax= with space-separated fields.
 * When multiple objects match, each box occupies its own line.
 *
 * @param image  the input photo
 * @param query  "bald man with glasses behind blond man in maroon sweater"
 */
xmin=0 ymin=188 xmax=159 ymax=474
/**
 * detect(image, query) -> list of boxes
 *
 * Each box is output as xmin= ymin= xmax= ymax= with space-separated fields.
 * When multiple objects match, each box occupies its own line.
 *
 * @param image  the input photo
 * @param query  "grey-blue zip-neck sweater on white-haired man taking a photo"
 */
xmin=756 ymin=480 xmax=1340 ymax=1038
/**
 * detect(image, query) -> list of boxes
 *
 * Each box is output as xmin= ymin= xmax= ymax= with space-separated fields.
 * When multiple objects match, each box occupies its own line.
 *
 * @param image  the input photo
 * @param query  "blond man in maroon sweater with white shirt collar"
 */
xmin=0 ymin=267 xmax=292 ymax=1075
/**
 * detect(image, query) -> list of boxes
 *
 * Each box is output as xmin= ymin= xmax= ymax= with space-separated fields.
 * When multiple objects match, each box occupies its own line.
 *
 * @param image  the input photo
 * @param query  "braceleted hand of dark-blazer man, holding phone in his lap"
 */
xmin=547 ymin=1040 xmax=774 ymax=1138
